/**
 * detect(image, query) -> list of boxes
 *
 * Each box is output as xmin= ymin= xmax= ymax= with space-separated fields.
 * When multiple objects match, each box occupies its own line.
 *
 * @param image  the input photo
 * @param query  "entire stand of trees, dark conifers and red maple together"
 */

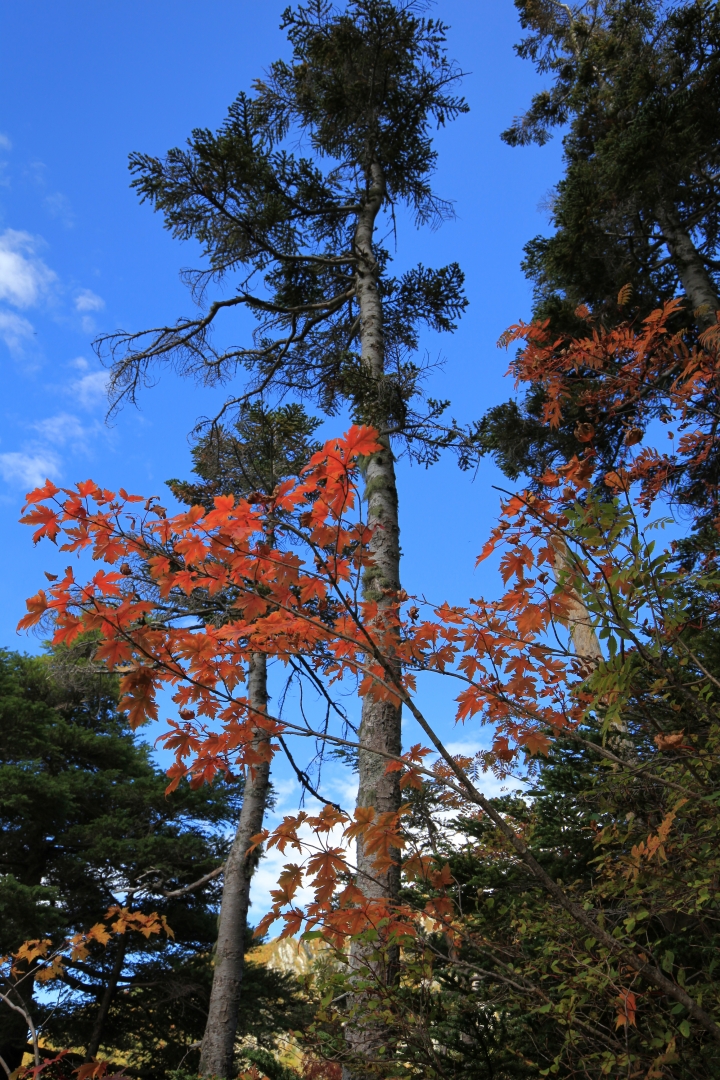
xmin=5 ymin=0 xmax=720 ymax=1080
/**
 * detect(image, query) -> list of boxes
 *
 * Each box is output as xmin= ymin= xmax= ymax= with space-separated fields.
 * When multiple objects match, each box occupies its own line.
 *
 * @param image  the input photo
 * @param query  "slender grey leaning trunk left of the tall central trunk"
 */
xmin=200 ymin=652 xmax=270 ymax=1080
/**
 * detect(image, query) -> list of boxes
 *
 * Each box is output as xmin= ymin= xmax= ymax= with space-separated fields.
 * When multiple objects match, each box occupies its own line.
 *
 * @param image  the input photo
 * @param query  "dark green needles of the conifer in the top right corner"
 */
xmin=477 ymin=0 xmax=720 ymax=477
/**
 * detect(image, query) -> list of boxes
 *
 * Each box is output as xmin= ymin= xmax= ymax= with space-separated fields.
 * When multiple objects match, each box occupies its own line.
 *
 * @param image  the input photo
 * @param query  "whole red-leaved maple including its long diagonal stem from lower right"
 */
xmin=15 ymin=358 xmax=720 ymax=1075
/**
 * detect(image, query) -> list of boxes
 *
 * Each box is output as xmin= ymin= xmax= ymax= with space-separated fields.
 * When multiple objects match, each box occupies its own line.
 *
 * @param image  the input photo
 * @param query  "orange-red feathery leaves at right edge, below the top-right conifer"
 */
xmin=501 ymin=289 xmax=720 ymax=529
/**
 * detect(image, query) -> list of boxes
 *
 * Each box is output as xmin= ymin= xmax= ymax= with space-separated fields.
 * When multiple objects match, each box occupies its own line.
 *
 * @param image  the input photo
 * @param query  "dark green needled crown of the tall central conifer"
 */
xmin=100 ymin=0 xmax=466 ymax=460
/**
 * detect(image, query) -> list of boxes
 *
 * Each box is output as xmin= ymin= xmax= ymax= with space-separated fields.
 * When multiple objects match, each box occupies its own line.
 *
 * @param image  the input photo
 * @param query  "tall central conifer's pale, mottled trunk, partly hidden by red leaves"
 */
xmin=343 ymin=163 xmax=402 ymax=1078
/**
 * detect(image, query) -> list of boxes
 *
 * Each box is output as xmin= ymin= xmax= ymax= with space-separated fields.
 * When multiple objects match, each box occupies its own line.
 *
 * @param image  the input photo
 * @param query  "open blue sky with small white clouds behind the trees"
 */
xmin=0 ymin=0 xmax=561 ymax=911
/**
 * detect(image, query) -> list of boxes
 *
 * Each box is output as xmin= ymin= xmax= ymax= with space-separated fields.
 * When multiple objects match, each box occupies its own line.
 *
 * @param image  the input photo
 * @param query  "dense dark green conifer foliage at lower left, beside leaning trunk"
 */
xmin=0 ymin=643 xmax=310 ymax=1077
